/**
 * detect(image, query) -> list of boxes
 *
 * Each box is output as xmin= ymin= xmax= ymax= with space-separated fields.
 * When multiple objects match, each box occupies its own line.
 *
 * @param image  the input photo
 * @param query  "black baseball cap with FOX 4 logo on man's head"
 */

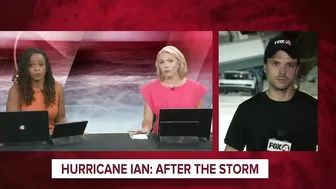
xmin=264 ymin=36 xmax=300 ymax=64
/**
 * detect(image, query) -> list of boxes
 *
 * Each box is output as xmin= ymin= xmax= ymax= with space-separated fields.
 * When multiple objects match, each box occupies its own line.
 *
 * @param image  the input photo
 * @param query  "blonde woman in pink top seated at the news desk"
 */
xmin=133 ymin=46 xmax=207 ymax=134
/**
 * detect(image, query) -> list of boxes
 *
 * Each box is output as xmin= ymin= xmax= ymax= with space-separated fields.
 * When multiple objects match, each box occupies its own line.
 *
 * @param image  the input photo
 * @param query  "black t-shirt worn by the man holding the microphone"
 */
xmin=224 ymin=91 xmax=317 ymax=151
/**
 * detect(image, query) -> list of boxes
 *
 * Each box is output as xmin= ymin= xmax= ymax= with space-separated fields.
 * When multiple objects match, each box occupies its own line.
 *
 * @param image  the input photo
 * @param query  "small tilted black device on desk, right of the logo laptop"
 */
xmin=50 ymin=121 xmax=88 ymax=145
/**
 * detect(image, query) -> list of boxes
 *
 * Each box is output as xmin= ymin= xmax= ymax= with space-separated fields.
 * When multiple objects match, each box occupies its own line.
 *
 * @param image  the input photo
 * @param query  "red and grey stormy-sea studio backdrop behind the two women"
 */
xmin=0 ymin=31 xmax=213 ymax=133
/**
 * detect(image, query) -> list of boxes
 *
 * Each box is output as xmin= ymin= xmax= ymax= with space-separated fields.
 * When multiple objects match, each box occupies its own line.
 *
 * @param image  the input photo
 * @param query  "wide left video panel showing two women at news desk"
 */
xmin=0 ymin=31 xmax=213 ymax=151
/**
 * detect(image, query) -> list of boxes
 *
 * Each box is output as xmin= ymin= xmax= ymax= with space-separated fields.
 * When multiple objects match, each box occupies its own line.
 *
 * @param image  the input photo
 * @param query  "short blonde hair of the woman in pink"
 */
xmin=155 ymin=46 xmax=188 ymax=81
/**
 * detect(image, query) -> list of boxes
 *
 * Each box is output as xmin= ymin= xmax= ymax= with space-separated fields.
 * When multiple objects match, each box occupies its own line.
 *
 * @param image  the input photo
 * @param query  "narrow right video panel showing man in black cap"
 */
xmin=218 ymin=31 xmax=318 ymax=151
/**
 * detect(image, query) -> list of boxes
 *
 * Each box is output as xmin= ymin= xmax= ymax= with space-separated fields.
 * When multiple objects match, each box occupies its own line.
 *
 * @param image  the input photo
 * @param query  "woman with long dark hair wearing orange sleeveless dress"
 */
xmin=6 ymin=48 xmax=67 ymax=135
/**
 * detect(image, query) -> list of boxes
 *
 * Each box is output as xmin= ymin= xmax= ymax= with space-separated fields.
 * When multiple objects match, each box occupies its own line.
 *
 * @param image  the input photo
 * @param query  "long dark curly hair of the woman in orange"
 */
xmin=12 ymin=48 xmax=56 ymax=107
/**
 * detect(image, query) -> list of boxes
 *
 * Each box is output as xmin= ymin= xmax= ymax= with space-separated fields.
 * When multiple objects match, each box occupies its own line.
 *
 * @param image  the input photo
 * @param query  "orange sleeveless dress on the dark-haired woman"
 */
xmin=21 ymin=87 xmax=59 ymax=135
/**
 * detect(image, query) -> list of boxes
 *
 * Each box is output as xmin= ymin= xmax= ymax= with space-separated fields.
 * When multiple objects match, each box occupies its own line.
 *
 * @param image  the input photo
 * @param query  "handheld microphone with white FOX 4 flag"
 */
xmin=267 ymin=130 xmax=292 ymax=151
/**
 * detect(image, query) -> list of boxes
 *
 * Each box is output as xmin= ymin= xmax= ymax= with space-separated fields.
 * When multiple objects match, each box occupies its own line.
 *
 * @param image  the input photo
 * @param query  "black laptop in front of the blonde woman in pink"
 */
xmin=158 ymin=109 xmax=212 ymax=143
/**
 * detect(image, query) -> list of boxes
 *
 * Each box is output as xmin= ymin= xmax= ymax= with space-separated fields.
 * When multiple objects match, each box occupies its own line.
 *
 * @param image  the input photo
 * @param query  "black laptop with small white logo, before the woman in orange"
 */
xmin=0 ymin=111 xmax=49 ymax=144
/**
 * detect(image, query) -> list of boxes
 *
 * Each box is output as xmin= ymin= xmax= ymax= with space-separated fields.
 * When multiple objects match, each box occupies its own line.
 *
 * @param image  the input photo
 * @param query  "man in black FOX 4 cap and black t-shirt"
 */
xmin=224 ymin=36 xmax=317 ymax=151
